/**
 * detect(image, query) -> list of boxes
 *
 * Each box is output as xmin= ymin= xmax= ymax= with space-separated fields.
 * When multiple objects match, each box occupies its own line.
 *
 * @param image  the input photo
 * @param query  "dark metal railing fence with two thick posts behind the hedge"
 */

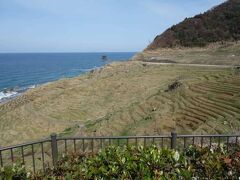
xmin=0 ymin=132 xmax=240 ymax=172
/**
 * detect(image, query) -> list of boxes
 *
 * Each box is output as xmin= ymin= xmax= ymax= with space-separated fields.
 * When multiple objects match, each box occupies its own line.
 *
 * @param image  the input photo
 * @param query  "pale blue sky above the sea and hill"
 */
xmin=0 ymin=0 xmax=225 ymax=53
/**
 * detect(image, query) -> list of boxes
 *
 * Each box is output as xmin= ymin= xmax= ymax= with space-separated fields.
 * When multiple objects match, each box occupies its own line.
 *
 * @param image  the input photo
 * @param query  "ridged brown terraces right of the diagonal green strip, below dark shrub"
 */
xmin=85 ymin=69 xmax=240 ymax=135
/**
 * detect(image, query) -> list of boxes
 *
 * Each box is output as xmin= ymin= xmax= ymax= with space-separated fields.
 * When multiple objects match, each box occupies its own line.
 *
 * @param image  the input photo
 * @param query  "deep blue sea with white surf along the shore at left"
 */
xmin=0 ymin=52 xmax=135 ymax=102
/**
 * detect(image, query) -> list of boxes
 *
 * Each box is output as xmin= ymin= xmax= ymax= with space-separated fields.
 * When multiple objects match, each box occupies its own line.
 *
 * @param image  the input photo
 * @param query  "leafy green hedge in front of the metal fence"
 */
xmin=0 ymin=146 xmax=240 ymax=179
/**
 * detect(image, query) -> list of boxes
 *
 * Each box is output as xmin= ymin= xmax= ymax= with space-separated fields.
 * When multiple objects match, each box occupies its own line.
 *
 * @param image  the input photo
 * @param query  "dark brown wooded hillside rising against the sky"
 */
xmin=145 ymin=0 xmax=240 ymax=51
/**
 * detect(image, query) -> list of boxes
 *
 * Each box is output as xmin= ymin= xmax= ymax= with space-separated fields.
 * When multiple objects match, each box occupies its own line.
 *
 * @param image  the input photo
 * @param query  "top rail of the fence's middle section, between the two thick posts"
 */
xmin=57 ymin=135 xmax=171 ymax=141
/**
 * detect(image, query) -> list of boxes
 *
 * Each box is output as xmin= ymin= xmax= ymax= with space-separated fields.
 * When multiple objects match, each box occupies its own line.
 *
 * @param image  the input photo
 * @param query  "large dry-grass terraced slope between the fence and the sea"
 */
xmin=0 ymin=59 xmax=240 ymax=145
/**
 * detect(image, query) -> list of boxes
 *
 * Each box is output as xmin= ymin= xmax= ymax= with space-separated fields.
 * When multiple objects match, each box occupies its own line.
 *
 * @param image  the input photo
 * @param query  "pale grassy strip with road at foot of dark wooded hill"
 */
xmin=134 ymin=41 xmax=240 ymax=65
